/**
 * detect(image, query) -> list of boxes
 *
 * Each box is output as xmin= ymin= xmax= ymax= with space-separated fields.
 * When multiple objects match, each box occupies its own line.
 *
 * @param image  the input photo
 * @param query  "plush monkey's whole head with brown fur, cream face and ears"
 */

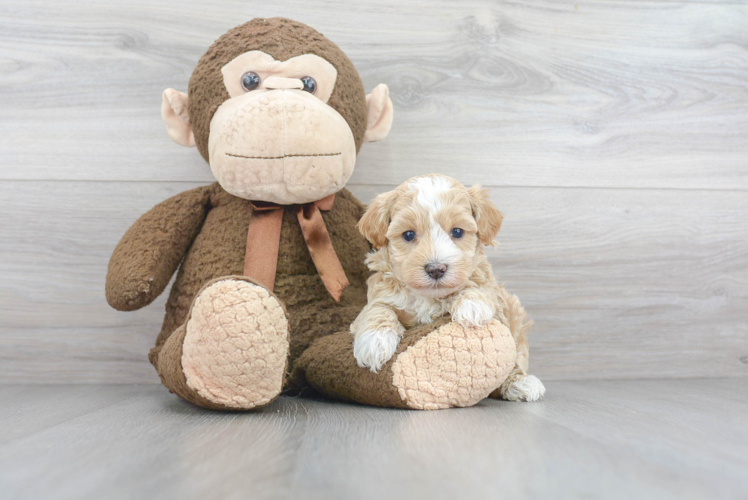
xmin=161 ymin=18 xmax=393 ymax=204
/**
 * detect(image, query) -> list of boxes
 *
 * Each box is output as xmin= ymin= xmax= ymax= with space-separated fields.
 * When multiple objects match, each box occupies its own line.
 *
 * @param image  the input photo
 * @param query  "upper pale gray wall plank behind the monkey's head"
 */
xmin=0 ymin=0 xmax=748 ymax=190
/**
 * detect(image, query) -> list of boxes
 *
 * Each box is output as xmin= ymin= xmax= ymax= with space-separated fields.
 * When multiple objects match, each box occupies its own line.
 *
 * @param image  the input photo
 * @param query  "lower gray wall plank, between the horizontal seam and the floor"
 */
xmin=0 ymin=181 xmax=748 ymax=383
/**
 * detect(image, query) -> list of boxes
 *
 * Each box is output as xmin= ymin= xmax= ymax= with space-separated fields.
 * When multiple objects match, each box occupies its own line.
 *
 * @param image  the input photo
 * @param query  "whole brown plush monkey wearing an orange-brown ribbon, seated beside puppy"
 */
xmin=106 ymin=18 xmax=515 ymax=410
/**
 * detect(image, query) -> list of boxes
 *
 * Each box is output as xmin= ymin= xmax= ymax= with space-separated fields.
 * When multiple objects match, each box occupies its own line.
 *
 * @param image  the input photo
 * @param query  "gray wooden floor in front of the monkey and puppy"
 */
xmin=0 ymin=379 xmax=748 ymax=500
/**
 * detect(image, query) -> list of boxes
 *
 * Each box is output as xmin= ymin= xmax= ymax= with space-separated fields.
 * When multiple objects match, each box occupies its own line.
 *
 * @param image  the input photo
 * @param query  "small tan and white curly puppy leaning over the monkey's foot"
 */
xmin=351 ymin=175 xmax=545 ymax=401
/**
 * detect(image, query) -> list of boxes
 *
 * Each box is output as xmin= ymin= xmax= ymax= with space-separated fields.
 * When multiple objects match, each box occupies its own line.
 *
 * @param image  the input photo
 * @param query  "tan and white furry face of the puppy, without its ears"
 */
xmin=387 ymin=175 xmax=480 ymax=297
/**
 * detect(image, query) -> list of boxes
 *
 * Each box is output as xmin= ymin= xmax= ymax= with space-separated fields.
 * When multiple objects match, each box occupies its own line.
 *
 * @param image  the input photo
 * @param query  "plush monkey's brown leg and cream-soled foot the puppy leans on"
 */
xmin=292 ymin=318 xmax=517 ymax=410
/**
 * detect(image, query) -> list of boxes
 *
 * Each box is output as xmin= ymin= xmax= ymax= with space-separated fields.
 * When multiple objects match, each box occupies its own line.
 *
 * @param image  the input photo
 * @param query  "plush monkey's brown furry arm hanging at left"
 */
xmin=106 ymin=186 xmax=212 ymax=311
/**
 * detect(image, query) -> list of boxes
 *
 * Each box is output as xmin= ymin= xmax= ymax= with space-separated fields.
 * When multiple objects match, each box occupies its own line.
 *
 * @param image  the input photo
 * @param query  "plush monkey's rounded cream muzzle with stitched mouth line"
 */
xmin=208 ymin=90 xmax=356 ymax=205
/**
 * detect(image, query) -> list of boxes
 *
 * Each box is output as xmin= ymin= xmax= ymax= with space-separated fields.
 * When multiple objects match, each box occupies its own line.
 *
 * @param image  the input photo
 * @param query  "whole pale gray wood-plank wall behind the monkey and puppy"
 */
xmin=0 ymin=0 xmax=748 ymax=383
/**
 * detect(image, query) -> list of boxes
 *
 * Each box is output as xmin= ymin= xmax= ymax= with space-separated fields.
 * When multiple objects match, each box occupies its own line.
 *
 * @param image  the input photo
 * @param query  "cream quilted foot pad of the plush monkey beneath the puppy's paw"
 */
xmin=392 ymin=320 xmax=517 ymax=410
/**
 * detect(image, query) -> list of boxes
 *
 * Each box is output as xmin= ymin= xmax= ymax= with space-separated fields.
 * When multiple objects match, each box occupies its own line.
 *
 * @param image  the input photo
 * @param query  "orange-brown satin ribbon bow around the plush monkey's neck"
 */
xmin=244 ymin=194 xmax=349 ymax=302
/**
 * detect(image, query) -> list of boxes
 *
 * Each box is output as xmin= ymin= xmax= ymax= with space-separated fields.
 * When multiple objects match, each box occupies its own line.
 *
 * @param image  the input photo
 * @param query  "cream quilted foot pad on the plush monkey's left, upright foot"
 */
xmin=182 ymin=279 xmax=289 ymax=409
